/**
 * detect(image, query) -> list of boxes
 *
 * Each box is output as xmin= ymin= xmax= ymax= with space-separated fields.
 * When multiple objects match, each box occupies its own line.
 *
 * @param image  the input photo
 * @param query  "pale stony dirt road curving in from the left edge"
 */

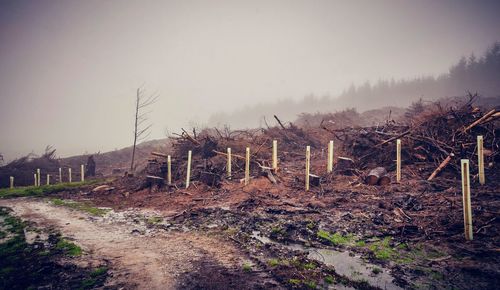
xmin=0 ymin=199 xmax=254 ymax=289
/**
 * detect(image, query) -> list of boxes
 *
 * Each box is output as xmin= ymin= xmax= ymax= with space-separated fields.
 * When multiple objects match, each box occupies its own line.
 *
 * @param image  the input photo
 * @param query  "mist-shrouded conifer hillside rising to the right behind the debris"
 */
xmin=208 ymin=42 xmax=500 ymax=128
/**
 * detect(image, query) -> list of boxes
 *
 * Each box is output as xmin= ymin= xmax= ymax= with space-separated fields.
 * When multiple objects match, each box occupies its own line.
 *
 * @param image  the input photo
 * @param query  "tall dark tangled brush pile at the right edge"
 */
xmin=335 ymin=97 xmax=500 ymax=179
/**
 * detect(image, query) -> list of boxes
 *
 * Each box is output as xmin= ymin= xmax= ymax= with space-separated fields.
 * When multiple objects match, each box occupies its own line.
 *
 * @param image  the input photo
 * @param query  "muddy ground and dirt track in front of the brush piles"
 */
xmin=0 ymin=168 xmax=500 ymax=289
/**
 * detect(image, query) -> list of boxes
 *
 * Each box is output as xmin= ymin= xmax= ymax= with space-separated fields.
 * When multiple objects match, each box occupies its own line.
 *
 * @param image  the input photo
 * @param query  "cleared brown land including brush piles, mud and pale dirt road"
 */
xmin=0 ymin=100 xmax=500 ymax=289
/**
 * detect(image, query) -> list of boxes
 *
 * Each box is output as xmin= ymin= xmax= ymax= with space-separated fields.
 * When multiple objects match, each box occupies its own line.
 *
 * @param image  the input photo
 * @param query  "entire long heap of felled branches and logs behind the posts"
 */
xmin=146 ymin=97 xmax=500 ymax=186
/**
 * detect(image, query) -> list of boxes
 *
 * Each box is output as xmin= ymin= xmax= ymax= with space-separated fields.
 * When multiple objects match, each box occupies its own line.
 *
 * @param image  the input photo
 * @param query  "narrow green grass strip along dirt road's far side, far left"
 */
xmin=0 ymin=180 xmax=102 ymax=198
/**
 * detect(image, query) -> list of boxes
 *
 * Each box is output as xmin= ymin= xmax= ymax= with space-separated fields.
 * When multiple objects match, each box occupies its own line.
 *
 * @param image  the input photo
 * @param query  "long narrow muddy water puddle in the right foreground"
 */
xmin=252 ymin=231 xmax=403 ymax=290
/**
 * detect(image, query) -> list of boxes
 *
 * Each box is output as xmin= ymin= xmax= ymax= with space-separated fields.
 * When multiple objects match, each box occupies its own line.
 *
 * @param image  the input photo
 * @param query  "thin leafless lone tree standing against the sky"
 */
xmin=130 ymin=87 xmax=159 ymax=173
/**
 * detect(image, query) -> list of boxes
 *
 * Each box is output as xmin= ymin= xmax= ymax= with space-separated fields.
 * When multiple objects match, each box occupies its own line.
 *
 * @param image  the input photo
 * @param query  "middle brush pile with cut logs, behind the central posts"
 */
xmin=146 ymin=117 xmax=320 ymax=186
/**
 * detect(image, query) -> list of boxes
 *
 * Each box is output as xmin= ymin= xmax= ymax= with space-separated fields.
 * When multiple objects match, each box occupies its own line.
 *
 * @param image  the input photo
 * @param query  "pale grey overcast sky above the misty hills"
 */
xmin=0 ymin=0 xmax=500 ymax=159
